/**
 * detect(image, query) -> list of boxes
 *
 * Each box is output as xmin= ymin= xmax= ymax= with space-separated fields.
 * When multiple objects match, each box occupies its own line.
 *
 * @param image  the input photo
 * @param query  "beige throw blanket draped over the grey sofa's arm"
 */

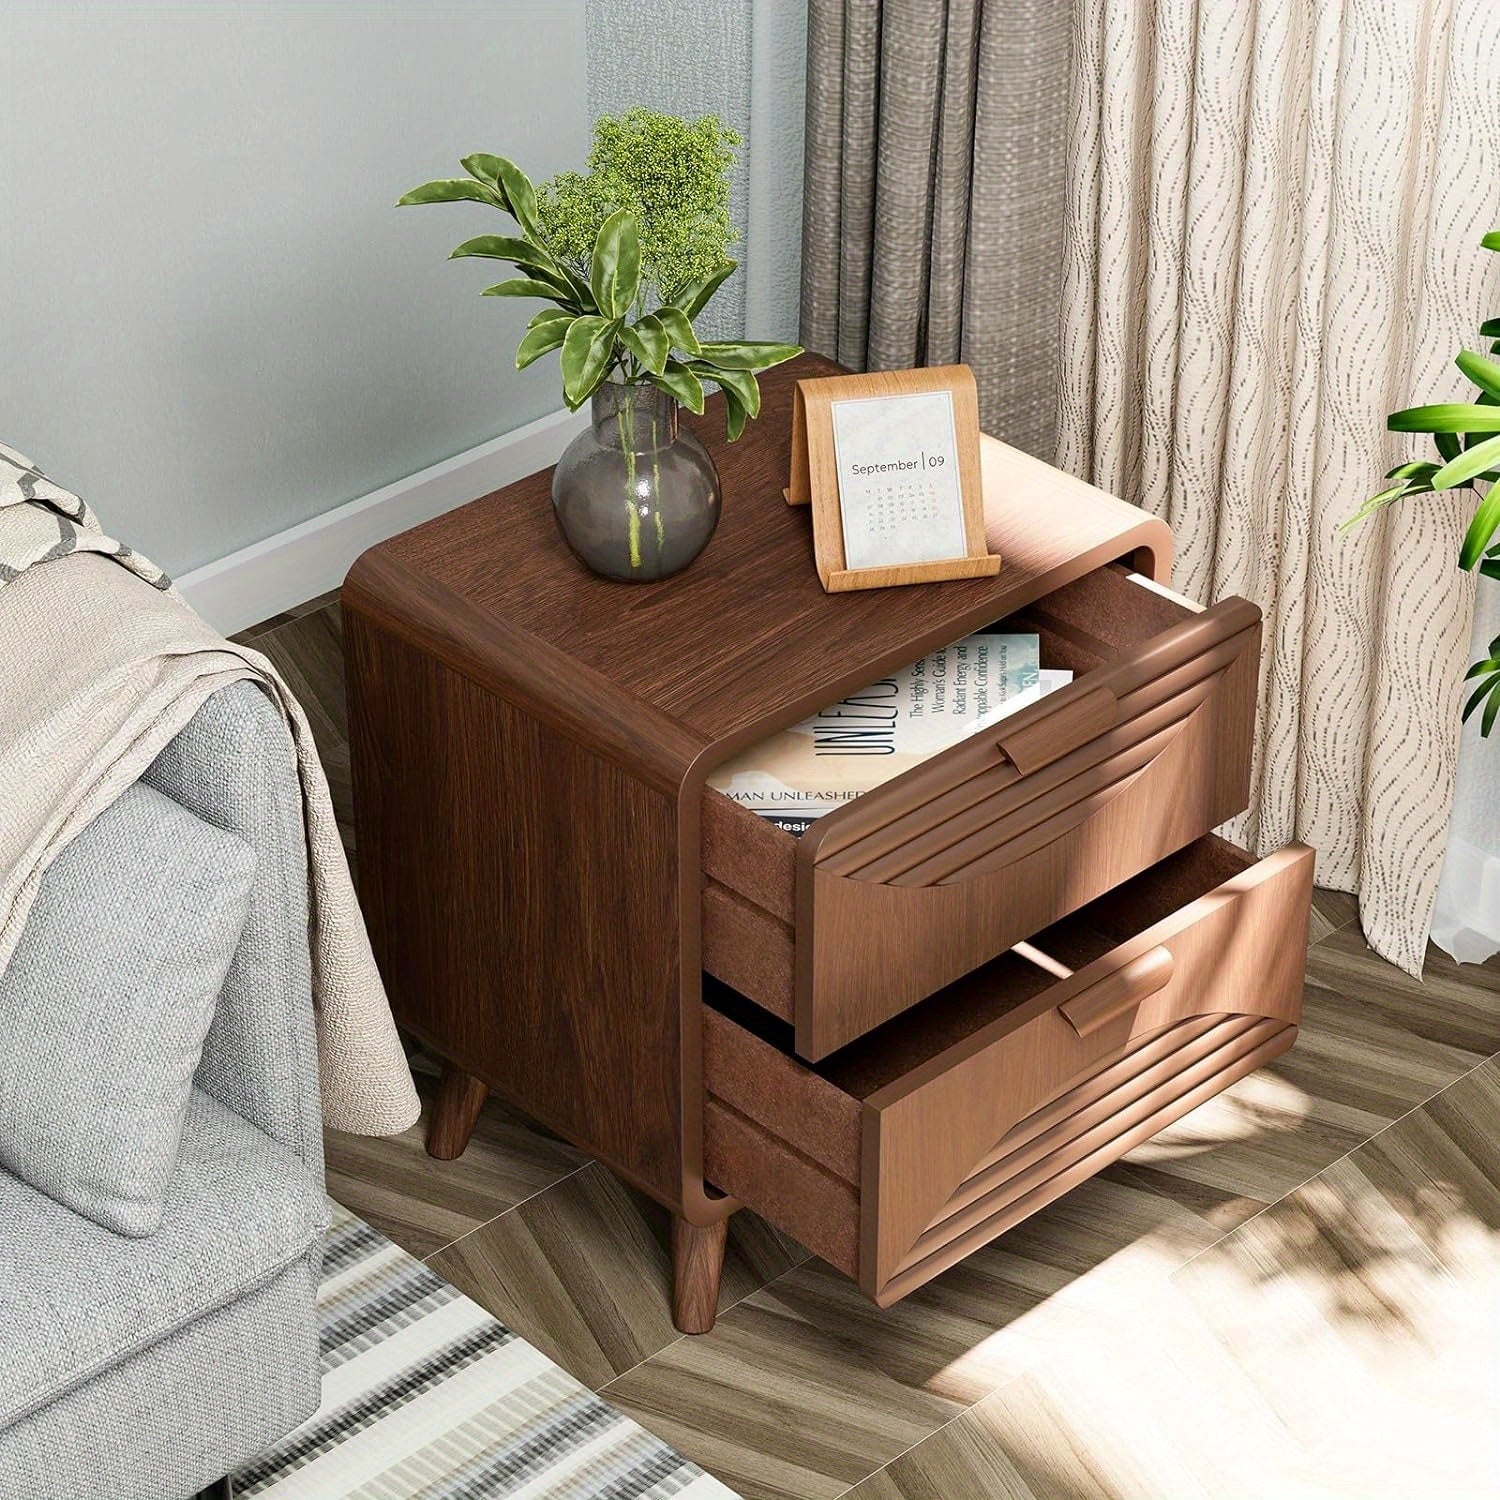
xmin=0 ymin=446 xmax=417 ymax=1136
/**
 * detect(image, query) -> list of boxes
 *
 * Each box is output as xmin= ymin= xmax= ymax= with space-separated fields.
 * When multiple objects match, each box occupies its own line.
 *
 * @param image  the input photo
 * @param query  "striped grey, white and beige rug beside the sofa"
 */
xmin=234 ymin=1205 xmax=735 ymax=1500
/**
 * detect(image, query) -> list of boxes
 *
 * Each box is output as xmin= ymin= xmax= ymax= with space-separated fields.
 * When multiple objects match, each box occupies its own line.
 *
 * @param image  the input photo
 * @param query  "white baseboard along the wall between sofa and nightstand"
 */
xmin=177 ymin=411 xmax=588 ymax=635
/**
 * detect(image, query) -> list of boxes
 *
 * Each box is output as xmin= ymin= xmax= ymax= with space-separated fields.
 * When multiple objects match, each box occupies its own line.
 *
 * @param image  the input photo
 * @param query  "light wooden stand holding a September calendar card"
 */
xmin=785 ymin=365 xmax=1001 ymax=594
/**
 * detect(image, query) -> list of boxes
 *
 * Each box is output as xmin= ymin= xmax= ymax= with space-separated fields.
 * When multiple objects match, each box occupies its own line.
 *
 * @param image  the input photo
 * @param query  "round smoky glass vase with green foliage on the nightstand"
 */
xmin=399 ymin=110 xmax=801 ymax=582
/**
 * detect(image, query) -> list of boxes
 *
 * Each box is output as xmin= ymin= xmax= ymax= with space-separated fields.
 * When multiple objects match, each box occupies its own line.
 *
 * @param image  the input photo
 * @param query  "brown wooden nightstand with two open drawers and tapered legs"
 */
xmin=344 ymin=357 xmax=1313 ymax=1332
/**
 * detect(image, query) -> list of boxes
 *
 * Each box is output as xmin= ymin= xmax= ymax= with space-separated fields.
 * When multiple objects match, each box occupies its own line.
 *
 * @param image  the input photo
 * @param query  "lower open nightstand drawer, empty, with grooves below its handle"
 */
xmin=704 ymin=836 xmax=1313 ymax=1305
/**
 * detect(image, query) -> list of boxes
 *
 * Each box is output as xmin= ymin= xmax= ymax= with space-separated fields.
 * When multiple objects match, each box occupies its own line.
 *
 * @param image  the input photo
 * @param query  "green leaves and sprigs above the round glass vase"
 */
xmin=399 ymin=110 xmax=803 ymax=443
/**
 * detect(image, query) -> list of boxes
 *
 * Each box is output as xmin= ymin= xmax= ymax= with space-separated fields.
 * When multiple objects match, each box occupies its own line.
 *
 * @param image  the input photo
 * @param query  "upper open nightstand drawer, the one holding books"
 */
xmin=702 ymin=566 xmax=1260 ymax=1062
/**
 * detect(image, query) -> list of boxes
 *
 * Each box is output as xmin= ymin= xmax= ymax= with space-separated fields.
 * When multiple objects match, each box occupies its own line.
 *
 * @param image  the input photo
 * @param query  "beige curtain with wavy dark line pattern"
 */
xmin=1059 ymin=0 xmax=1500 ymax=974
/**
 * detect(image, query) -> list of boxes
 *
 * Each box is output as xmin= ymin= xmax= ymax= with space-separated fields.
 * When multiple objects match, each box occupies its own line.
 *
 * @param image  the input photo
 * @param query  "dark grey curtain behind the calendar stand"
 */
xmin=801 ymin=0 xmax=1070 ymax=459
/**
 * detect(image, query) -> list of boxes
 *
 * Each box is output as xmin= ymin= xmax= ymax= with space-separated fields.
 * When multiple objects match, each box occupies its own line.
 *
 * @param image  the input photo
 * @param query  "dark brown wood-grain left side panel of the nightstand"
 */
xmin=344 ymin=608 xmax=683 ymax=1203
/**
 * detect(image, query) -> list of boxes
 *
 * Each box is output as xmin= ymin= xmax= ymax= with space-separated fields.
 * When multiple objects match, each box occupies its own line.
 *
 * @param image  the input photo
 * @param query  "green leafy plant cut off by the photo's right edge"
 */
xmin=1341 ymin=230 xmax=1500 ymax=735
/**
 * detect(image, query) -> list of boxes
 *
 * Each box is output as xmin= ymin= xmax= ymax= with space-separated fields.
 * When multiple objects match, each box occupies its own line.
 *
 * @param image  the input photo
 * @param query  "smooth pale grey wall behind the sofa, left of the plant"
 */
xmin=0 ymin=0 xmax=588 ymax=573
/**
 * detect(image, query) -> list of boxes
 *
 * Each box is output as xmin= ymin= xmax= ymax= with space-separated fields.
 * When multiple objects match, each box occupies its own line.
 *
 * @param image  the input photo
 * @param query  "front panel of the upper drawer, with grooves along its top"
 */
xmin=794 ymin=599 xmax=1260 ymax=1062
